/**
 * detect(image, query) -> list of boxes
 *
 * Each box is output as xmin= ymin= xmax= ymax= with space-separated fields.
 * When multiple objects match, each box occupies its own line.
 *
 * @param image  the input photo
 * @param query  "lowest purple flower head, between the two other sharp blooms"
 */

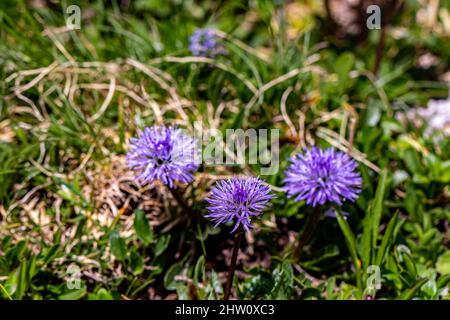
xmin=206 ymin=177 xmax=273 ymax=232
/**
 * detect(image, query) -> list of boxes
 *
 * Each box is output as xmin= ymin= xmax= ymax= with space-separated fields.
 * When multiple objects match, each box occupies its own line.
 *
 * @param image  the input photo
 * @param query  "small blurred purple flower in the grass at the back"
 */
xmin=189 ymin=28 xmax=223 ymax=58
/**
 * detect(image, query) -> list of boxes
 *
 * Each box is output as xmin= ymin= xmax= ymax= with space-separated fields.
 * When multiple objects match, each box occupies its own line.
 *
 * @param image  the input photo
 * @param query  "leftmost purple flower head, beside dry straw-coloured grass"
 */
xmin=126 ymin=125 xmax=199 ymax=188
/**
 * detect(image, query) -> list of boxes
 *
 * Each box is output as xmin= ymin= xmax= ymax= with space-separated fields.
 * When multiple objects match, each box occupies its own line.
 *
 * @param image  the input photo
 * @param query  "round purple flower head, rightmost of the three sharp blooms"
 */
xmin=284 ymin=148 xmax=362 ymax=207
